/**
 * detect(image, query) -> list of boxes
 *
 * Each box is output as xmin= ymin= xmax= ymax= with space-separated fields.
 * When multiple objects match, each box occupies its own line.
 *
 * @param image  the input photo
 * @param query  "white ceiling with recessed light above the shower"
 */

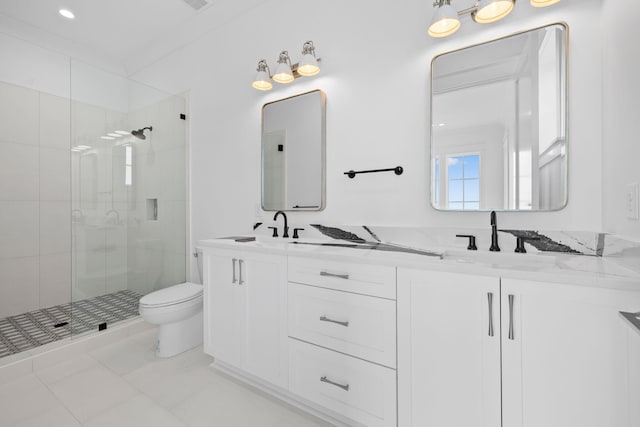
xmin=0 ymin=0 xmax=236 ymax=72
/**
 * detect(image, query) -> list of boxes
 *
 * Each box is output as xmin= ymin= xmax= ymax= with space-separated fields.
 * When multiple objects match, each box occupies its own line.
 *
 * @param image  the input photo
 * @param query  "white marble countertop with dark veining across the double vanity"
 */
xmin=198 ymin=225 xmax=640 ymax=291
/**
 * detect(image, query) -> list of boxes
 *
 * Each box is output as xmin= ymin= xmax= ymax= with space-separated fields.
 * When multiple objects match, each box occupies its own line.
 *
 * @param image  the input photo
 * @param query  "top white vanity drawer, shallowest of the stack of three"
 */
xmin=288 ymin=257 xmax=396 ymax=300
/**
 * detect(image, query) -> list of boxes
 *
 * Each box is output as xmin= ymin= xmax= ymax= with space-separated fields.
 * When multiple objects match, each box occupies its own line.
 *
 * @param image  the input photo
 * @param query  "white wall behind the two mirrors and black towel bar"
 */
xmin=134 ymin=0 xmax=608 ymax=272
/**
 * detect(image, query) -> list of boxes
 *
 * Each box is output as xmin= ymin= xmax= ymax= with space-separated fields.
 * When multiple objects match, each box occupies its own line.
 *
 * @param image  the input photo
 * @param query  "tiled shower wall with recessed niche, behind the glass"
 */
xmin=128 ymin=97 xmax=186 ymax=294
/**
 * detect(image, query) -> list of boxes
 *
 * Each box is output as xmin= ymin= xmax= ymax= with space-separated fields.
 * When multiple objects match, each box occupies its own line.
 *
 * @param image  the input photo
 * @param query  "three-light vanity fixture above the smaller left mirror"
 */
xmin=251 ymin=40 xmax=321 ymax=90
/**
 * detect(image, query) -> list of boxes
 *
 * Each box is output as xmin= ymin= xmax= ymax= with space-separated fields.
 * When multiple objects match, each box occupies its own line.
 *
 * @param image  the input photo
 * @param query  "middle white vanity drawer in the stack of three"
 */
xmin=288 ymin=282 xmax=396 ymax=368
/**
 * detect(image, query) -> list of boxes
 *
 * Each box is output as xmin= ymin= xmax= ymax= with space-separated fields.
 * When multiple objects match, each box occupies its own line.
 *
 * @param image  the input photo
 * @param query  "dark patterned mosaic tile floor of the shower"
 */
xmin=0 ymin=290 xmax=142 ymax=357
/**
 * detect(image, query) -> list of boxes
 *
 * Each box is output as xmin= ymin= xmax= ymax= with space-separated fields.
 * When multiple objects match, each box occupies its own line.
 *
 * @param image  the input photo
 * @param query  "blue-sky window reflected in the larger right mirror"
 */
xmin=447 ymin=154 xmax=480 ymax=210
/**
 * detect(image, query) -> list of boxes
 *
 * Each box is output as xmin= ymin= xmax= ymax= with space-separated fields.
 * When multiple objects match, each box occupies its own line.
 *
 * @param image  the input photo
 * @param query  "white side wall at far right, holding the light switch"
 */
xmin=602 ymin=0 xmax=640 ymax=239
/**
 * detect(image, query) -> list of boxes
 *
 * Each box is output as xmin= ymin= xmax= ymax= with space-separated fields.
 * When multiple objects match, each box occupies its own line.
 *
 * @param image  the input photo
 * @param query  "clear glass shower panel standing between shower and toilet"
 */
xmin=70 ymin=61 xmax=187 ymax=334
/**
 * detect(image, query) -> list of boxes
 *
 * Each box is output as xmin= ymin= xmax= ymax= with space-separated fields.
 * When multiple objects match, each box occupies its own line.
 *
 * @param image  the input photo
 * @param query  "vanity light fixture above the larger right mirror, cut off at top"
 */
xmin=428 ymin=0 xmax=560 ymax=38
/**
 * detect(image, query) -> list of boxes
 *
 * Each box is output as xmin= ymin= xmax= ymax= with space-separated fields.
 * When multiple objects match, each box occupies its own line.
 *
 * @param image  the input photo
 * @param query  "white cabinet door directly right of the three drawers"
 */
xmin=397 ymin=269 xmax=500 ymax=427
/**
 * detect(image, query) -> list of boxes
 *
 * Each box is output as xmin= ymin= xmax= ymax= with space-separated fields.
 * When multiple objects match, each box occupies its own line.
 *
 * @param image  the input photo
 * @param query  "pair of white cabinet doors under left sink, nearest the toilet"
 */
xmin=204 ymin=248 xmax=288 ymax=388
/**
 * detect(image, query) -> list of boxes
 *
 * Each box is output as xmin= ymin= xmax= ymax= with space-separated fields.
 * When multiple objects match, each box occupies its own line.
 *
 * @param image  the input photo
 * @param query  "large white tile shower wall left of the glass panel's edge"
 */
xmin=0 ymin=83 xmax=71 ymax=317
